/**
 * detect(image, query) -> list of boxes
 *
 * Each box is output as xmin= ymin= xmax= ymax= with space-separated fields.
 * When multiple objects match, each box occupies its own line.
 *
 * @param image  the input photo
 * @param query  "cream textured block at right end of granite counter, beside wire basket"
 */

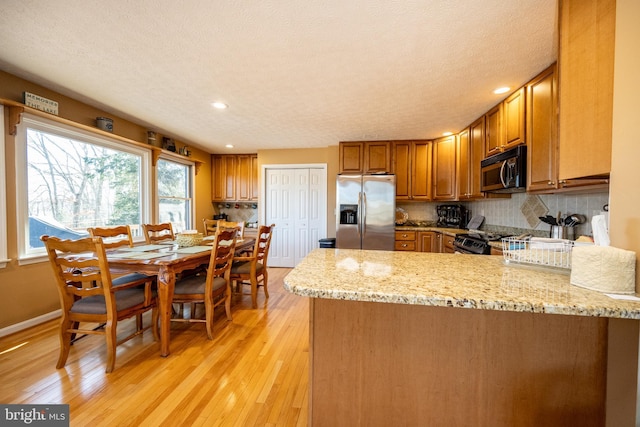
xmin=571 ymin=245 xmax=636 ymax=294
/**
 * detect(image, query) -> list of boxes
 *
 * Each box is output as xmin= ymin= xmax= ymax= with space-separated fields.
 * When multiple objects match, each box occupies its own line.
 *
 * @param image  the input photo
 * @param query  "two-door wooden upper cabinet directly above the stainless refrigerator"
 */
xmin=340 ymin=141 xmax=391 ymax=174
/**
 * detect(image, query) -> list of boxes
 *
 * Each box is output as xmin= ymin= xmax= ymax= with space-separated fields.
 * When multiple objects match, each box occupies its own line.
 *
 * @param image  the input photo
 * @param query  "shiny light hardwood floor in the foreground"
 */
xmin=0 ymin=268 xmax=309 ymax=427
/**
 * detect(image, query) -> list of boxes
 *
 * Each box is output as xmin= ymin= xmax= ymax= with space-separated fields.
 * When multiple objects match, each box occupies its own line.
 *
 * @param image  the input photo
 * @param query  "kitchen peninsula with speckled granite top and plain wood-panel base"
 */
xmin=285 ymin=249 xmax=640 ymax=426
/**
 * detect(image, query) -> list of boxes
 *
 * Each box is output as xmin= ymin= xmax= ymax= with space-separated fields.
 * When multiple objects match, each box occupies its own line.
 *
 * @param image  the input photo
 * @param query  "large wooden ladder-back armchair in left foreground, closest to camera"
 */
xmin=41 ymin=236 xmax=159 ymax=373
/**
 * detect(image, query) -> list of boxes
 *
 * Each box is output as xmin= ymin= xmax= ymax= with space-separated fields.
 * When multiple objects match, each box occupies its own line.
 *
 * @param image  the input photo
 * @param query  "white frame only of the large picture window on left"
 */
xmin=15 ymin=113 xmax=152 ymax=265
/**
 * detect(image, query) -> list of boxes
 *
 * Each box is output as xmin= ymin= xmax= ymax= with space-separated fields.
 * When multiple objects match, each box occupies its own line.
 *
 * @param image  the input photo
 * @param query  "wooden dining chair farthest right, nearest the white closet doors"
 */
xmin=231 ymin=224 xmax=275 ymax=308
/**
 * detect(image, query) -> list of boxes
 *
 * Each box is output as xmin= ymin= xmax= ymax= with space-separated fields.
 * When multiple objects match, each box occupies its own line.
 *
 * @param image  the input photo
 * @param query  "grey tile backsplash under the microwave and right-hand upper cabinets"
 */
xmin=396 ymin=192 xmax=609 ymax=237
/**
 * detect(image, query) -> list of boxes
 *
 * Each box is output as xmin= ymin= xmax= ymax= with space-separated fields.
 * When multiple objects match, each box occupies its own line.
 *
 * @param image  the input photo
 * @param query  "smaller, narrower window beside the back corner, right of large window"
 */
xmin=157 ymin=159 xmax=194 ymax=232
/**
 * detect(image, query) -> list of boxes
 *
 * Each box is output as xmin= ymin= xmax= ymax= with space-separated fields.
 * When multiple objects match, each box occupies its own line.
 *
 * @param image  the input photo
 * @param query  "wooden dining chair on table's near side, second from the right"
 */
xmin=171 ymin=229 xmax=236 ymax=340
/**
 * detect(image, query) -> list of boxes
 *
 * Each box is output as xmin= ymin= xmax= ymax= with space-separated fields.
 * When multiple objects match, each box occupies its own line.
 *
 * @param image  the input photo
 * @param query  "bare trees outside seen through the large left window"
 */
xmin=27 ymin=128 xmax=142 ymax=248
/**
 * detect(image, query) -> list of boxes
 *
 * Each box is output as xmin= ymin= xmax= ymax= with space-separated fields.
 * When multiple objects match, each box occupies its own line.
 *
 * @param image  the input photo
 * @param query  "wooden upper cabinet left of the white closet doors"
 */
xmin=211 ymin=154 xmax=259 ymax=202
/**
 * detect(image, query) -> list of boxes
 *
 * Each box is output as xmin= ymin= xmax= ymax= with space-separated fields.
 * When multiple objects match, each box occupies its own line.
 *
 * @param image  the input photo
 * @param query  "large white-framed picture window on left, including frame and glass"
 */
xmin=16 ymin=114 xmax=150 ymax=261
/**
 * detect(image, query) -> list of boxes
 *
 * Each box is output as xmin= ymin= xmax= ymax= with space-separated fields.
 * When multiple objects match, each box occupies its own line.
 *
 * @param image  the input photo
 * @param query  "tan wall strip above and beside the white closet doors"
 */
xmin=258 ymin=147 xmax=338 ymax=237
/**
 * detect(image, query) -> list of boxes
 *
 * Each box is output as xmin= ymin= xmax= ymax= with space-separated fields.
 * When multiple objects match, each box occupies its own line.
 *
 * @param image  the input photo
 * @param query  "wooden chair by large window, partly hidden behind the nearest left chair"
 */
xmin=87 ymin=225 xmax=156 ymax=328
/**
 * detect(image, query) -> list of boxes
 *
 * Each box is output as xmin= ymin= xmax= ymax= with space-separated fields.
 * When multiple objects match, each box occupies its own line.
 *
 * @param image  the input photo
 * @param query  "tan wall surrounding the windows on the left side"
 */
xmin=0 ymin=71 xmax=213 ymax=332
